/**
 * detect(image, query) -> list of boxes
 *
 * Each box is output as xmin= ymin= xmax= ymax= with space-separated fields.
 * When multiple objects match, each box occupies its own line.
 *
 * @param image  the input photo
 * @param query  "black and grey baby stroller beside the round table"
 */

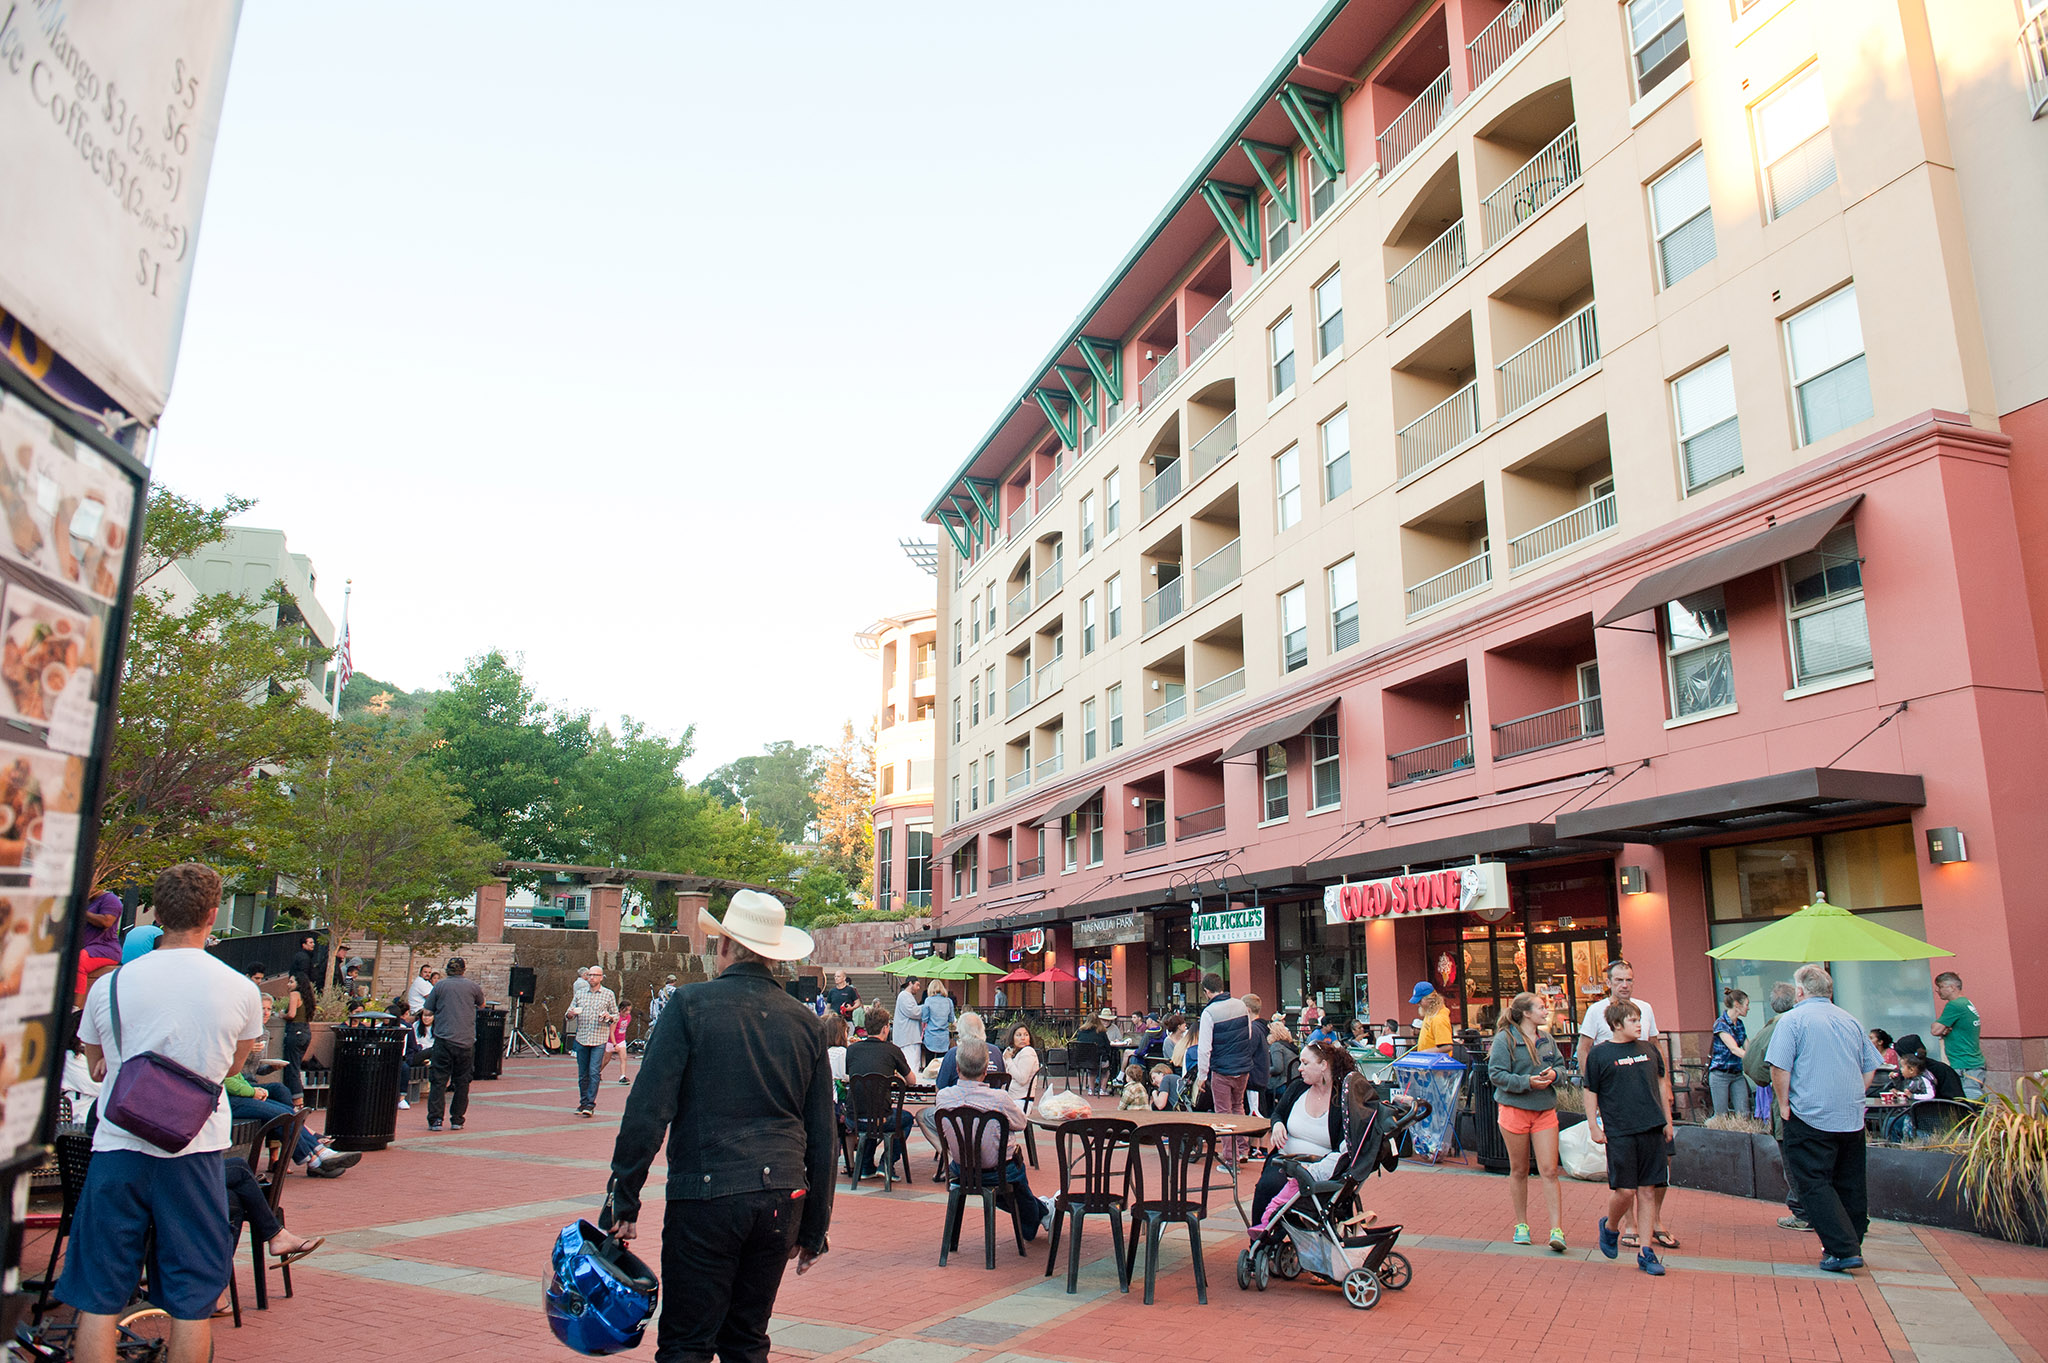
xmin=1237 ymin=1099 xmax=1430 ymax=1312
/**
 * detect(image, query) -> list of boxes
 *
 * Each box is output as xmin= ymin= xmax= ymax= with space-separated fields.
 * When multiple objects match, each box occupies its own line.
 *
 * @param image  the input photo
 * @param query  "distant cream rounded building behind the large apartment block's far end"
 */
xmin=854 ymin=610 xmax=937 ymax=909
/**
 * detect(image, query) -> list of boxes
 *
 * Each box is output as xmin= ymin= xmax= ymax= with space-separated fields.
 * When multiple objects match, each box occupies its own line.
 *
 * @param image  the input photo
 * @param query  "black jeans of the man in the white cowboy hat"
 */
xmin=653 ymin=1189 xmax=803 ymax=1363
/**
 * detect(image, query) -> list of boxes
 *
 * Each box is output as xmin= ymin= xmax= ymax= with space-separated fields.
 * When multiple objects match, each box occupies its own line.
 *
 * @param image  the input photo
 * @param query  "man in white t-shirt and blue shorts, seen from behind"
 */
xmin=57 ymin=862 xmax=262 ymax=1363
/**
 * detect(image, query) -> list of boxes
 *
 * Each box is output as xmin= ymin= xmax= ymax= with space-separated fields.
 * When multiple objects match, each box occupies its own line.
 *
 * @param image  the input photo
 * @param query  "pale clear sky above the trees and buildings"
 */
xmin=154 ymin=0 xmax=1317 ymax=778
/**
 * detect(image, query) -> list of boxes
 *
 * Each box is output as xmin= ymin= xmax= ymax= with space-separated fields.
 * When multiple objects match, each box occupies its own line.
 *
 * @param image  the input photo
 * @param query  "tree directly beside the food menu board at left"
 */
xmin=92 ymin=489 xmax=330 ymax=886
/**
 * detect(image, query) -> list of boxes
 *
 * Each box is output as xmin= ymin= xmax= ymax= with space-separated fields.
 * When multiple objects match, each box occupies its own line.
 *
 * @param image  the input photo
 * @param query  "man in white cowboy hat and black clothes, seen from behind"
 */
xmin=600 ymin=890 xmax=838 ymax=1363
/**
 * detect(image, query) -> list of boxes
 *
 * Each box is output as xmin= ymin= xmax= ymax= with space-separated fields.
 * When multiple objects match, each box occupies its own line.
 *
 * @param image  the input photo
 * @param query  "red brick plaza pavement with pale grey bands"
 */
xmin=56 ymin=1060 xmax=2048 ymax=1363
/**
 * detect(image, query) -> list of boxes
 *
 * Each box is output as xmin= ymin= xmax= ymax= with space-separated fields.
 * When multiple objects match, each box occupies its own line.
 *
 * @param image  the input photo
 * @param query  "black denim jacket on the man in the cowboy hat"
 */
xmin=608 ymin=962 xmax=838 ymax=1252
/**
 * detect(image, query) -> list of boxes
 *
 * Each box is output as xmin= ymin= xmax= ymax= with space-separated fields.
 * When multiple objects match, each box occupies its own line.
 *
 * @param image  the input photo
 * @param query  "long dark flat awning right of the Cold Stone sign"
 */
xmin=1556 ymin=767 xmax=1927 ymax=843
